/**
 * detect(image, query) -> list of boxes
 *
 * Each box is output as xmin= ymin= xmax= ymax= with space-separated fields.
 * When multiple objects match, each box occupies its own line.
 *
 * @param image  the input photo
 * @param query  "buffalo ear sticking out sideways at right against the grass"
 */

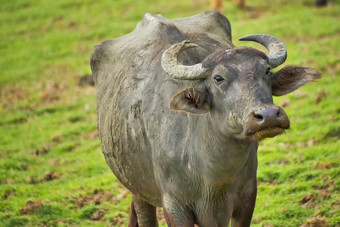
xmin=272 ymin=66 xmax=321 ymax=96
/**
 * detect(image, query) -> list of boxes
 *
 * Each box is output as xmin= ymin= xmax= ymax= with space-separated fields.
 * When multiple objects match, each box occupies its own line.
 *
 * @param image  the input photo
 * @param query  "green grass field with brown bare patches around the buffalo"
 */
xmin=0 ymin=0 xmax=340 ymax=226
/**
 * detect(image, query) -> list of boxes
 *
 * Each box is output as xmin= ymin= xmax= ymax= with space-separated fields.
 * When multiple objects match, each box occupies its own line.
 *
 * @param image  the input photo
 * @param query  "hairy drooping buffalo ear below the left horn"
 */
xmin=169 ymin=88 xmax=210 ymax=114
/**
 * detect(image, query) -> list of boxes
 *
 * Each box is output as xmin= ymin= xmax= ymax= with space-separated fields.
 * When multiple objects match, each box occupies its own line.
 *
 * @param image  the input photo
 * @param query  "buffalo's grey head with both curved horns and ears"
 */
xmin=161 ymin=35 xmax=321 ymax=140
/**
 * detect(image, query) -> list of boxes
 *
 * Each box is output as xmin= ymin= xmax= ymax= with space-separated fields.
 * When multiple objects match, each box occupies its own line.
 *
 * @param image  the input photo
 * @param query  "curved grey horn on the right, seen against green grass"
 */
xmin=239 ymin=34 xmax=287 ymax=68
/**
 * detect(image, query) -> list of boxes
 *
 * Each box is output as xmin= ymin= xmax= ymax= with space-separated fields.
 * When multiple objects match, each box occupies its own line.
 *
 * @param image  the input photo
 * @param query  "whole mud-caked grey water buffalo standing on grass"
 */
xmin=91 ymin=12 xmax=321 ymax=227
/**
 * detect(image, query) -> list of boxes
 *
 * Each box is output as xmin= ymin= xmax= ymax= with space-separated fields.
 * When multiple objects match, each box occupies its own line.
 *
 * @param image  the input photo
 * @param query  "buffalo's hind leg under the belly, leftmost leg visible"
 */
xmin=129 ymin=194 xmax=158 ymax=227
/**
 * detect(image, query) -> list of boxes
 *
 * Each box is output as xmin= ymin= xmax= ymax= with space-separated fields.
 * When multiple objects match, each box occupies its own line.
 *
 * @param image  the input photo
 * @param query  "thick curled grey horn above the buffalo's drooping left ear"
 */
xmin=161 ymin=40 xmax=207 ymax=80
